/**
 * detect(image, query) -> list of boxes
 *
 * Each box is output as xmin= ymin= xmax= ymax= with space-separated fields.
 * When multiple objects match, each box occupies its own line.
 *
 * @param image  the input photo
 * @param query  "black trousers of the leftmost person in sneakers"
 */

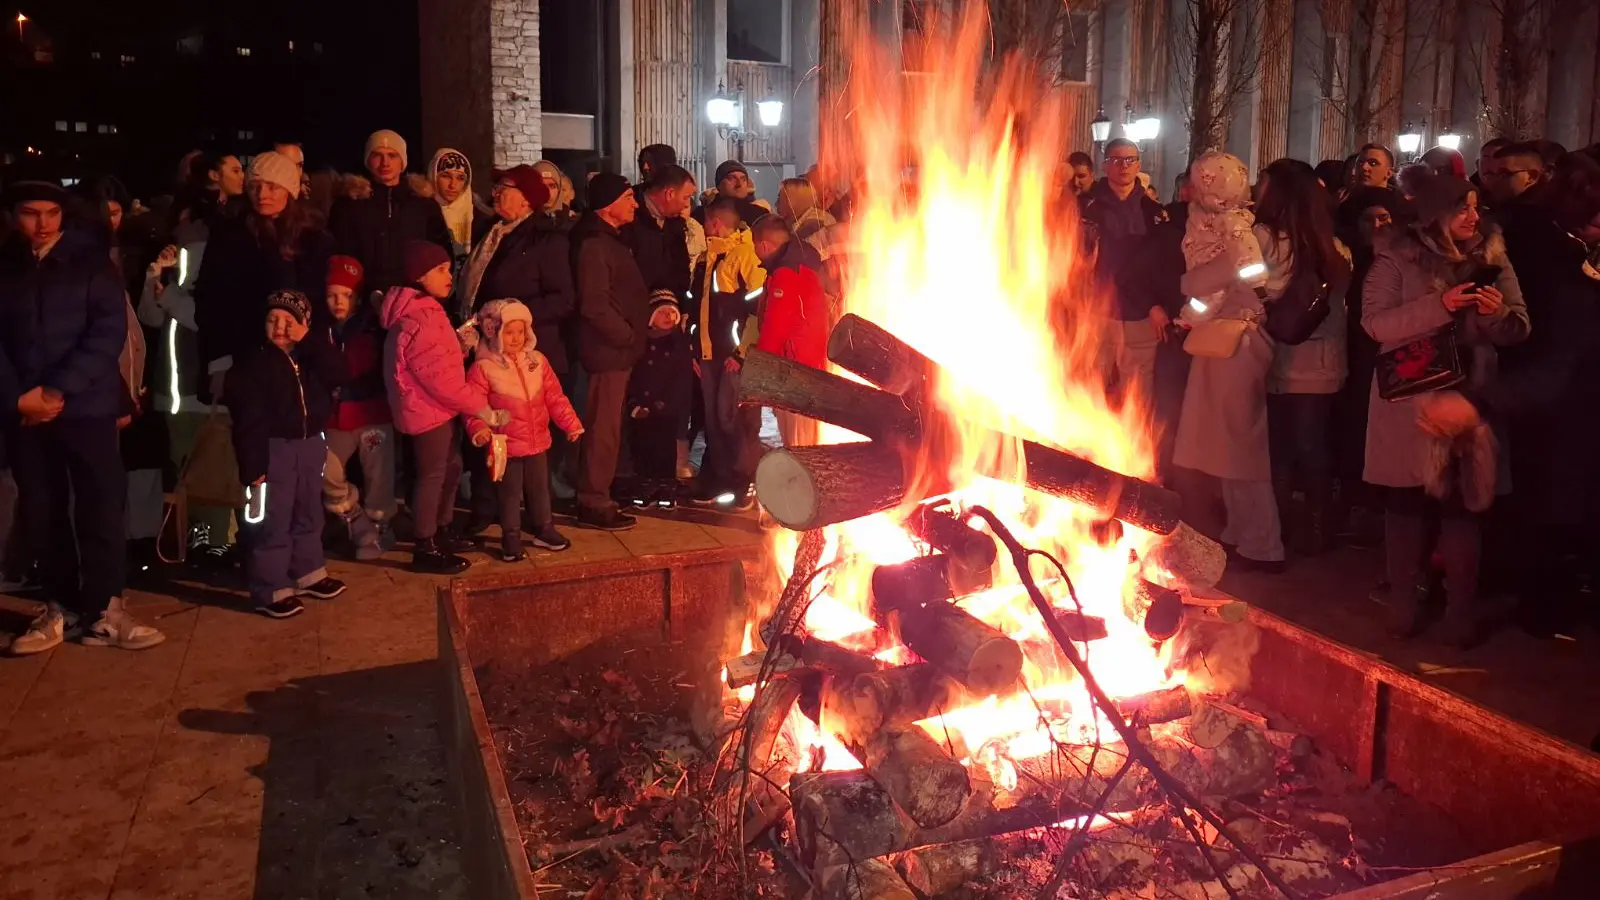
xmin=11 ymin=416 xmax=128 ymax=623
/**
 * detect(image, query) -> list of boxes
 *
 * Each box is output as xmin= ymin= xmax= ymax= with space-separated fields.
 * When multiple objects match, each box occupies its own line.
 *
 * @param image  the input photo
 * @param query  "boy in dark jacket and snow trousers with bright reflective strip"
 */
xmin=226 ymin=291 xmax=344 ymax=618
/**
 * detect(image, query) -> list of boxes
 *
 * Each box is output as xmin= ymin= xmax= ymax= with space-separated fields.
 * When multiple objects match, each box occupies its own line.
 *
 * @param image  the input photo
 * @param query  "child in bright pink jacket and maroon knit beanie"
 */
xmin=379 ymin=240 xmax=504 ymax=575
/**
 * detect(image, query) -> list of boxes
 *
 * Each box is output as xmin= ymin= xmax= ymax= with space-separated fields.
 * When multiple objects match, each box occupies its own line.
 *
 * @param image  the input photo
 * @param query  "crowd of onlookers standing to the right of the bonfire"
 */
xmin=1062 ymin=139 xmax=1600 ymax=647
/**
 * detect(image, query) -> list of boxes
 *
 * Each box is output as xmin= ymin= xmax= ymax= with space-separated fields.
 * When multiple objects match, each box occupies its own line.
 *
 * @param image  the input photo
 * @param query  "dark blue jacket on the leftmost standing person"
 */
xmin=0 ymin=227 xmax=128 ymax=418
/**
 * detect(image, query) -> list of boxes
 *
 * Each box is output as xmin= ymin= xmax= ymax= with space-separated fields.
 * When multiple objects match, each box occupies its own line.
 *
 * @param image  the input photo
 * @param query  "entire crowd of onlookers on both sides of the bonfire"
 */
xmin=0 ymin=124 xmax=1600 ymax=653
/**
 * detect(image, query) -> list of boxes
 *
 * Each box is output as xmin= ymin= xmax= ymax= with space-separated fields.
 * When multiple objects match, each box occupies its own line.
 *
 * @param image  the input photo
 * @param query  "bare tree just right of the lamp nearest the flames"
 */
xmin=1168 ymin=0 xmax=1269 ymax=159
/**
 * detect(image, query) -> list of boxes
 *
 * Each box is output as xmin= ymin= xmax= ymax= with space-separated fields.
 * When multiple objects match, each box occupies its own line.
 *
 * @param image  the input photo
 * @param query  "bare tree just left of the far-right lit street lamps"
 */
xmin=1302 ymin=0 xmax=1450 ymax=147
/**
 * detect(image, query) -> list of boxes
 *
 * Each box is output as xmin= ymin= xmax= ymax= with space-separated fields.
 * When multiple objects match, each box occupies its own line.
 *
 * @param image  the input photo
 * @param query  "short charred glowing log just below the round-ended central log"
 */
xmin=822 ymin=663 xmax=968 ymax=743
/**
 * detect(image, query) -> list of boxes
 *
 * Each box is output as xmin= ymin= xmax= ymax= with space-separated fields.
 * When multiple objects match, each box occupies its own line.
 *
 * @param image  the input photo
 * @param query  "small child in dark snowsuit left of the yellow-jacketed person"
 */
xmin=624 ymin=290 xmax=694 ymax=506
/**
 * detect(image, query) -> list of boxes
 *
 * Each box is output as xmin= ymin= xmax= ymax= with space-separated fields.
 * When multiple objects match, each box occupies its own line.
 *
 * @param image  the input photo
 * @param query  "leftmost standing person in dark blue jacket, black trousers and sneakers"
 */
xmin=0 ymin=183 xmax=163 ymax=653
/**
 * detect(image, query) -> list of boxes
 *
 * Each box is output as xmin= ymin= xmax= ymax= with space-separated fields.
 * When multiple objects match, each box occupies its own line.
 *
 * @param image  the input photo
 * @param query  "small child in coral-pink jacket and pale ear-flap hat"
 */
xmin=467 ymin=299 xmax=584 ymax=562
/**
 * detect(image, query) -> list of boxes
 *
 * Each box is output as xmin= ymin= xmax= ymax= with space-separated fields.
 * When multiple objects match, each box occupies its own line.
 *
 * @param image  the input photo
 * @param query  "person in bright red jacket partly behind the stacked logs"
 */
xmin=750 ymin=216 xmax=834 ymax=447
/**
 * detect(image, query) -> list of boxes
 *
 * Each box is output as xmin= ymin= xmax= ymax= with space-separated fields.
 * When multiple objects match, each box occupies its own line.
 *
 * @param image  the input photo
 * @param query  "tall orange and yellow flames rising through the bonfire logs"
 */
xmin=736 ymin=5 xmax=1181 ymax=778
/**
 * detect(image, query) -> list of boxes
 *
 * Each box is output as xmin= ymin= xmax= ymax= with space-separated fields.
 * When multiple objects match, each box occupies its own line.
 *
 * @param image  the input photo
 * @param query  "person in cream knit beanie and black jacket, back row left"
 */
xmin=328 ymin=130 xmax=453 ymax=293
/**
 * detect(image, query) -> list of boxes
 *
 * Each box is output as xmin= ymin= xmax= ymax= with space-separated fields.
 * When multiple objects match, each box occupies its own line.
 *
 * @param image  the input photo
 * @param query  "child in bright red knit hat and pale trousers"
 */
xmin=322 ymin=256 xmax=395 ymax=560
